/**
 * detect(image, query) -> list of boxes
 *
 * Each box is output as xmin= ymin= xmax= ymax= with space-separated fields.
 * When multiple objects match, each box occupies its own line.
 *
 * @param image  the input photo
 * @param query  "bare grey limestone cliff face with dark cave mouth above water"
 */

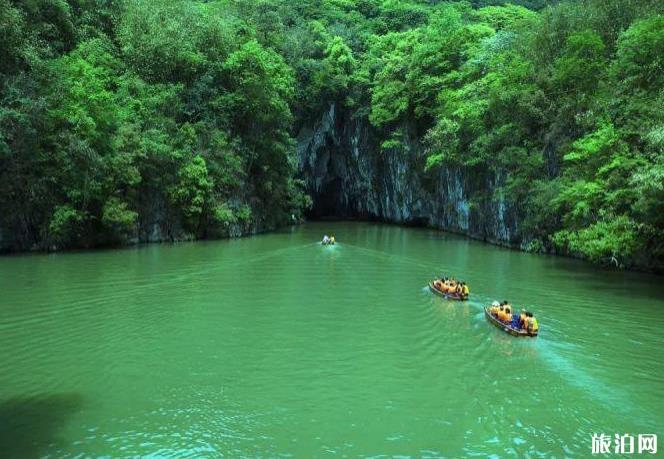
xmin=297 ymin=105 xmax=523 ymax=246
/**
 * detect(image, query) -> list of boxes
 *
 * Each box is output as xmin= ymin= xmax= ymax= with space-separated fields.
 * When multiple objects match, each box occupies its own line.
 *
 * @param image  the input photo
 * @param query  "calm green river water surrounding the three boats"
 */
xmin=0 ymin=223 xmax=664 ymax=457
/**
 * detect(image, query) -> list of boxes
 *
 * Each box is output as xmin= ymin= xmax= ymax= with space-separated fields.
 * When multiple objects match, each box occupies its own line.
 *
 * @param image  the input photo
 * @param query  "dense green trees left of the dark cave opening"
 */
xmin=0 ymin=0 xmax=306 ymax=248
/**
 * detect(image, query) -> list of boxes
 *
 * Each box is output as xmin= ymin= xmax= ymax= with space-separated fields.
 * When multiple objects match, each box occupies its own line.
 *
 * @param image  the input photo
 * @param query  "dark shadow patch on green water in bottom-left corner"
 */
xmin=0 ymin=394 xmax=83 ymax=458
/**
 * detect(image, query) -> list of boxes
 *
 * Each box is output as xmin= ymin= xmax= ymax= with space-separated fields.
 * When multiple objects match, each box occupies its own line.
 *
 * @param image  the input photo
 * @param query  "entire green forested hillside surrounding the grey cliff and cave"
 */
xmin=0 ymin=0 xmax=664 ymax=268
